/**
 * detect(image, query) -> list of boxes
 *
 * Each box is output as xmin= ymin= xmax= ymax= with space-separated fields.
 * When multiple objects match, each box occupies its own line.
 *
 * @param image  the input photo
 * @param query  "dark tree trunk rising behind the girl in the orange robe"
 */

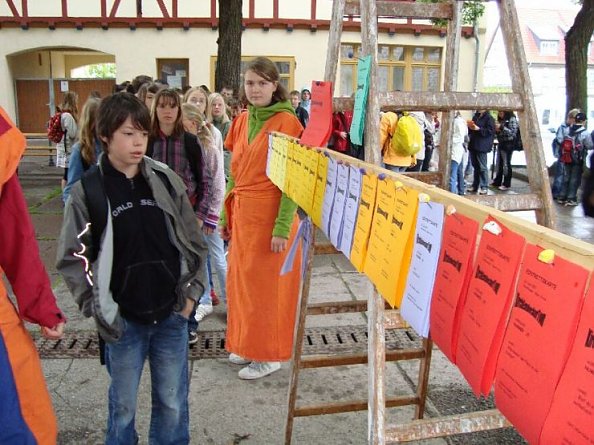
xmin=215 ymin=0 xmax=242 ymax=94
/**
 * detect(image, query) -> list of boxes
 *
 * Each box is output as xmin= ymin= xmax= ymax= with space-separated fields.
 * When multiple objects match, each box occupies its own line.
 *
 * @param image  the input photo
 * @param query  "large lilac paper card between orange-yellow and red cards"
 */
xmin=400 ymin=202 xmax=443 ymax=338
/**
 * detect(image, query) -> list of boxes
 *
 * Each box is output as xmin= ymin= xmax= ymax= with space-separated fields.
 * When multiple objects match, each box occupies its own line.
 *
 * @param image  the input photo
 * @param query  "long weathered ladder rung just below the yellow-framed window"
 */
xmin=333 ymin=91 xmax=524 ymax=111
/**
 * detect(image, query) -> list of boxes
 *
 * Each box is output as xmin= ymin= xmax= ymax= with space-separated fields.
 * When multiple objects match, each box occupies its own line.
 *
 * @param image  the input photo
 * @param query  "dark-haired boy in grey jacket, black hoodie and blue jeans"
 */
xmin=57 ymin=93 xmax=206 ymax=445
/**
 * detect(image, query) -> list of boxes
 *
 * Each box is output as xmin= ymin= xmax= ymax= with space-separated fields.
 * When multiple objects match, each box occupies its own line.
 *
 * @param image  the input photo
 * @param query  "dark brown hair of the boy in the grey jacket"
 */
xmin=97 ymin=92 xmax=151 ymax=153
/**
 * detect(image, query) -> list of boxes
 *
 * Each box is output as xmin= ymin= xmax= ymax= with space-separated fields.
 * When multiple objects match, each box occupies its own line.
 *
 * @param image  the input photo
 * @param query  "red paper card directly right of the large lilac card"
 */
xmin=429 ymin=213 xmax=478 ymax=363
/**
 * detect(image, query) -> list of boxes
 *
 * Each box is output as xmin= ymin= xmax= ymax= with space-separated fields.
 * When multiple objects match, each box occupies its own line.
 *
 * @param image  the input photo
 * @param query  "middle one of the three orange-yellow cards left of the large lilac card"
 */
xmin=363 ymin=178 xmax=396 ymax=301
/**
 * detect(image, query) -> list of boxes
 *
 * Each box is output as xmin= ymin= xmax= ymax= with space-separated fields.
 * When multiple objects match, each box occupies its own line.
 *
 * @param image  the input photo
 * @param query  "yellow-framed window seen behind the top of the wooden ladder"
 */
xmin=340 ymin=43 xmax=442 ymax=96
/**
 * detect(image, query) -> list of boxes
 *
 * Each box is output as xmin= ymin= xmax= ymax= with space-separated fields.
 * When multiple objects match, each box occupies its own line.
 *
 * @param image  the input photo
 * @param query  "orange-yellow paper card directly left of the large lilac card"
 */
xmin=386 ymin=187 xmax=419 ymax=307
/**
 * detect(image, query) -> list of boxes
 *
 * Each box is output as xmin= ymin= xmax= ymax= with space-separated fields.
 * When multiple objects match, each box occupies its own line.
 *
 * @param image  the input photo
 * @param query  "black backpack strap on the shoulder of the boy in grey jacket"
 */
xmin=81 ymin=165 xmax=108 ymax=262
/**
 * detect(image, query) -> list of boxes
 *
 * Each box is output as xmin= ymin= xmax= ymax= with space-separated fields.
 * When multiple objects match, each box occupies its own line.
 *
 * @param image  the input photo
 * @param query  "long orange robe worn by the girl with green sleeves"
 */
xmin=225 ymin=112 xmax=302 ymax=361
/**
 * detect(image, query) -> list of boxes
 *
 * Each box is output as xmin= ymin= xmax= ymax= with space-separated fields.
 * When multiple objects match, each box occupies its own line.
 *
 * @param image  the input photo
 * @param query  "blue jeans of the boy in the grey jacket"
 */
xmin=105 ymin=312 xmax=190 ymax=445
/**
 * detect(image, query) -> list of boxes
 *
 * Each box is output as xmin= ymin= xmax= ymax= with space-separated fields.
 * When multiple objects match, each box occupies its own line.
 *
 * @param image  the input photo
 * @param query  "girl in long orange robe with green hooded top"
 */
xmin=221 ymin=58 xmax=303 ymax=379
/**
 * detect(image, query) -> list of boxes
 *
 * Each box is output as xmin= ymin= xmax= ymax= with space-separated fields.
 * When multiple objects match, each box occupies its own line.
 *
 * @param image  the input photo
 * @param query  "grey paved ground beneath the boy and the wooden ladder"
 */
xmin=20 ymin=154 xmax=594 ymax=445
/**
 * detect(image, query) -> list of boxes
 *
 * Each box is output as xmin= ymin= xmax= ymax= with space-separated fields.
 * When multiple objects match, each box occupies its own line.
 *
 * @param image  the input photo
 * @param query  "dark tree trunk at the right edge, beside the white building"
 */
xmin=565 ymin=0 xmax=594 ymax=115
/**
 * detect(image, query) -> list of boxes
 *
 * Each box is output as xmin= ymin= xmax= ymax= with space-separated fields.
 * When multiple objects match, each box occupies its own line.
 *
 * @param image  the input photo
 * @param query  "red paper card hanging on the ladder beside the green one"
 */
xmin=300 ymin=81 xmax=332 ymax=147
